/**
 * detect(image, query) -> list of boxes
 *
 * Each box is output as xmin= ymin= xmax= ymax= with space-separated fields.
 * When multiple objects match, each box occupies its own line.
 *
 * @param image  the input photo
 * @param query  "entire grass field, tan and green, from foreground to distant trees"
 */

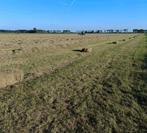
xmin=0 ymin=34 xmax=147 ymax=133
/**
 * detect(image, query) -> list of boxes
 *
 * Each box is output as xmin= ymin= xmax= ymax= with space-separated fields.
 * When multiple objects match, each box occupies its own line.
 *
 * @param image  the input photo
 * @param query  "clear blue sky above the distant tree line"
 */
xmin=0 ymin=0 xmax=147 ymax=30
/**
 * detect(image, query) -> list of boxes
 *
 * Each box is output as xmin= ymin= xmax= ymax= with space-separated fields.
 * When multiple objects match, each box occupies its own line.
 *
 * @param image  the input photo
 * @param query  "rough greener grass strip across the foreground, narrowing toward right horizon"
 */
xmin=0 ymin=35 xmax=147 ymax=133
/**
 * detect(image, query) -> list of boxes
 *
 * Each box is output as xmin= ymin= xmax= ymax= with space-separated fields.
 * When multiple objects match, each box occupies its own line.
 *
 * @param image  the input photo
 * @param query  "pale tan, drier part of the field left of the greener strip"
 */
xmin=0 ymin=34 xmax=133 ymax=88
